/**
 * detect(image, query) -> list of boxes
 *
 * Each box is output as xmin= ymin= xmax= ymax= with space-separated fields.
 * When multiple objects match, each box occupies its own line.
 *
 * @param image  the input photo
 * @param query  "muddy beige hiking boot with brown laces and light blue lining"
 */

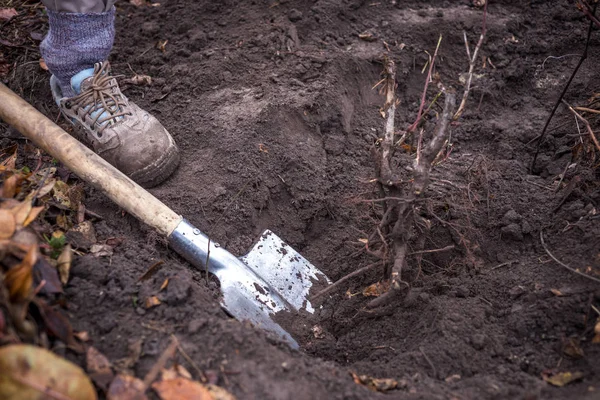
xmin=50 ymin=61 xmax=179 ymax=188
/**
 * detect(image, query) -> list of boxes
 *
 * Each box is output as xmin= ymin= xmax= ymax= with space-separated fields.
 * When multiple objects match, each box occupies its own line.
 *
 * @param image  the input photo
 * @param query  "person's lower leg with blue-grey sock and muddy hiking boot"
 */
xmin=40 ymin=0 xmax=179 ymax=187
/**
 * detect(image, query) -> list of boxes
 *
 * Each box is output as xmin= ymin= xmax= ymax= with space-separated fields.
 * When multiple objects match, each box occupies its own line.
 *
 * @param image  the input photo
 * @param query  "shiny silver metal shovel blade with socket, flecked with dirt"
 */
xmin=169 ymin=220 xmax=330 ymax=348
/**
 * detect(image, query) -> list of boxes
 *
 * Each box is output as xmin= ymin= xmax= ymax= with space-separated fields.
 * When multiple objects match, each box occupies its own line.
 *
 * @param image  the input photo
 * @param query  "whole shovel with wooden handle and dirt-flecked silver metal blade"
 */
xmin=0 ymin=83 xmax=330 ymax=348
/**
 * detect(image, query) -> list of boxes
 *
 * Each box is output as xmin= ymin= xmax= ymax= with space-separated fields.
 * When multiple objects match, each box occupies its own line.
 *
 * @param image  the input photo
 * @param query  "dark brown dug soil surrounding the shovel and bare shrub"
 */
xmin=0 ymin=0 xmax=600 ymax=399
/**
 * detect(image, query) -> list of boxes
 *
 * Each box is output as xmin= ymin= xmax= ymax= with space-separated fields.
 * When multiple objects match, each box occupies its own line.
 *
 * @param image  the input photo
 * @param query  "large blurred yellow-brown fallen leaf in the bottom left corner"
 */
xmin=0 ymin=344 xmax=97 ymax=400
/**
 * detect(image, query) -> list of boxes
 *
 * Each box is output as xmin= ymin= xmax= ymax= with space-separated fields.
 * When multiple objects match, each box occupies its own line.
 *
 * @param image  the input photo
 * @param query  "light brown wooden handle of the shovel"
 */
xmin=0 ymin=83 xmax=182 ymax=236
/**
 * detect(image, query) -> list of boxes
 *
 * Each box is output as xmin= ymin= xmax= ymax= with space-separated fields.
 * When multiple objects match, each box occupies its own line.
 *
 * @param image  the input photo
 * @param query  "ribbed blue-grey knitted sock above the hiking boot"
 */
xmin=40 ymin=7 xmax=115 ymax=97
